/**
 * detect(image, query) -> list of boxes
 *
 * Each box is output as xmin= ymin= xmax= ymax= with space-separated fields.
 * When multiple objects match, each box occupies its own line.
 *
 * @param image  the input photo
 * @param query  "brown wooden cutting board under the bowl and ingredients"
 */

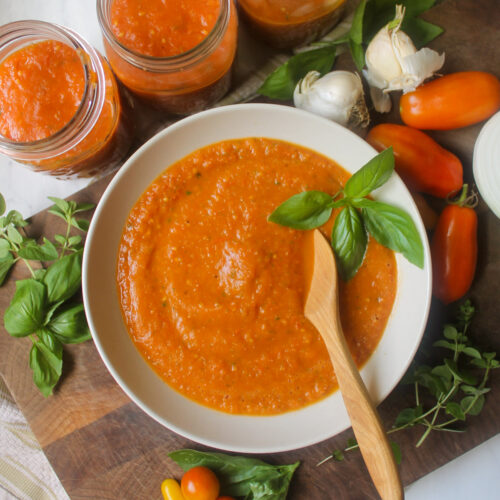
xmin=0 ymin=0 xmax=500 ymax=500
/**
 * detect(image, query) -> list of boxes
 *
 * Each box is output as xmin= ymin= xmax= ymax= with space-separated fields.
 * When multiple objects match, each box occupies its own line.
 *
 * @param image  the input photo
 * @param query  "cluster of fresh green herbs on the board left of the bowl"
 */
xmin=0 ymin=194 xmax=94 ymax=396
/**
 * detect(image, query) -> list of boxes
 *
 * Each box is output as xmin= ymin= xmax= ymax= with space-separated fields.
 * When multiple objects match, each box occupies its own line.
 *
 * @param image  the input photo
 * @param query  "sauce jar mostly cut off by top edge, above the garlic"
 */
xmin=238 ymin=0 xmax=345 ymax=49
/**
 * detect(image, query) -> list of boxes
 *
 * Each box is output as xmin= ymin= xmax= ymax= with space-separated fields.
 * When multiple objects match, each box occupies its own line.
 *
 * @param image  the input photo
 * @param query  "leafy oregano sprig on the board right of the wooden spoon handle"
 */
xmin=318 ymin=300 xmax=500 ymax=465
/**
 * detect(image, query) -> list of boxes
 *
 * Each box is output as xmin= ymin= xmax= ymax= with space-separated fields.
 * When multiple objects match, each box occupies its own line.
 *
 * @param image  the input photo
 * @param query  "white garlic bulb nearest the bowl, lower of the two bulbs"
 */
xmin=293 ymin=71 xmax=370 ymax=127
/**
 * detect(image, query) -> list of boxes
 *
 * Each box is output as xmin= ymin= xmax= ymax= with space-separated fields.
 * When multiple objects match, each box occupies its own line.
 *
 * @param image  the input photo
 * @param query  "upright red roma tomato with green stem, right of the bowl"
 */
xmin=431 ymin=184 xmax=477 ymax=304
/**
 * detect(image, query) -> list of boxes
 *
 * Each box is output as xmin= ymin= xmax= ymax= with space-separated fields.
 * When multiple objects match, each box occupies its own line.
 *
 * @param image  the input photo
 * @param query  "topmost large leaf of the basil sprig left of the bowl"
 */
xmin=43 ymin=251 xmax=82 ymax=304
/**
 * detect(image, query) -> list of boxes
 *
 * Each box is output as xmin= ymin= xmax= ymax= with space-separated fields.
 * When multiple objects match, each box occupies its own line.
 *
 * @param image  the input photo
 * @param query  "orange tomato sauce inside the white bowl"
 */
xmin=117 ymin=138 xmax=397 ymax=415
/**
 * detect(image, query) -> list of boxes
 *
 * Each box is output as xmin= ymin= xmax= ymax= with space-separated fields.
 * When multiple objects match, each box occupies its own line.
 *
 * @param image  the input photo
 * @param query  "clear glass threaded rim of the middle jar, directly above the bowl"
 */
xmin=96 ymin=0 xmax=232 ymax=73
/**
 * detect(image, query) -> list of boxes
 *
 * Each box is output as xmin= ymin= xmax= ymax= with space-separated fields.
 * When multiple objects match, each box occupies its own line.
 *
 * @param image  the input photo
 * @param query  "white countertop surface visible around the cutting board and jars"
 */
xmin=0 ymin=0 xmax=500 ymax=500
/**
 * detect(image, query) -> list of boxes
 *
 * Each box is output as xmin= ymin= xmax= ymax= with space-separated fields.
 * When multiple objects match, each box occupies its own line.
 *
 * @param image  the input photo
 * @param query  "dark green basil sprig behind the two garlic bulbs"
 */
xmin=257 ymin=0 xmax=443 ymax=100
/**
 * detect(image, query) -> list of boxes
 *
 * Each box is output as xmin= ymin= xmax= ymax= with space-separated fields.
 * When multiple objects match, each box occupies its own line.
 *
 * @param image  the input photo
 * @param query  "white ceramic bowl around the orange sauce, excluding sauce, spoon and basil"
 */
xmin=83 ymin=104 xmax=431 ymax=453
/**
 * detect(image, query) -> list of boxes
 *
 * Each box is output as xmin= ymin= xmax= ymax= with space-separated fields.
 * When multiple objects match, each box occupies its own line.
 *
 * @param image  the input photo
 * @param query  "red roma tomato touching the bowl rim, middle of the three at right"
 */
xmin=366 ymin=123 xmax=463 ymax=198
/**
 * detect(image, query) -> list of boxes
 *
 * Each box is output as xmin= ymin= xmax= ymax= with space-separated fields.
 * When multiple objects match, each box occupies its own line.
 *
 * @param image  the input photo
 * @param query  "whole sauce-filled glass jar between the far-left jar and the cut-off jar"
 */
xmin=97 ymin=0 xmax=238 ymax=114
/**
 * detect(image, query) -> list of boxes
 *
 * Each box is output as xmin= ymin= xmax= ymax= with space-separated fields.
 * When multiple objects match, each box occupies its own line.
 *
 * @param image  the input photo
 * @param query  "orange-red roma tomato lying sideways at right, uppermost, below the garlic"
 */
xmin=399 ymin=71 xmax=500 ymax=130
